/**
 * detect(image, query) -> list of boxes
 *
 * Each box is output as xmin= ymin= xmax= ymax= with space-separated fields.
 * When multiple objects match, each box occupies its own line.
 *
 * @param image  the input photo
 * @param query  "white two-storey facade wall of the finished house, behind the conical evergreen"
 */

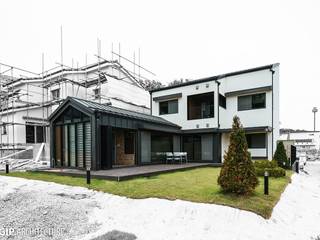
xmin=151 ymin=64 xmax=279 ymax=159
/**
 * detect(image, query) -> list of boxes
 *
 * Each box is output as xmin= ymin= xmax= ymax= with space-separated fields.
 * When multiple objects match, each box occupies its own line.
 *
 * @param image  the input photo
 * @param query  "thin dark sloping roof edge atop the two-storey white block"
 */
xmin=149 ymin=63 xmax=279 ymax=93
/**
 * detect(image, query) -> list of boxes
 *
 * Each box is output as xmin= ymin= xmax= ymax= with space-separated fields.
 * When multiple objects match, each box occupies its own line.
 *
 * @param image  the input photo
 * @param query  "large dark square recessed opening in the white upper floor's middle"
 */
xmin=188 ymin=92 xmax=214 ymax=120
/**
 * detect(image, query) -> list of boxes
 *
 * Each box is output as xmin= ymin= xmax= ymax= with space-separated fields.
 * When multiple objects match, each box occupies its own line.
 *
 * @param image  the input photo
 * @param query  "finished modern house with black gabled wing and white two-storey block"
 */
xmin=49 ymin=64 xmax=279 ymax=170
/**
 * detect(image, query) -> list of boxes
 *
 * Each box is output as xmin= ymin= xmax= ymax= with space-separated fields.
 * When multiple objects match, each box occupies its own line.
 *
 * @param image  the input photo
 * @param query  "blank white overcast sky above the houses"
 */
xmin=0 ymin=0 xmax=320 ymax=130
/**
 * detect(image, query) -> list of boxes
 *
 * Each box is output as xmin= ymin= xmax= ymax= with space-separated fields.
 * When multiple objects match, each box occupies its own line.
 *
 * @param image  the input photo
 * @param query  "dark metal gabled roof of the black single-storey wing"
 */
xmin=49 ymin=97 xmax=181 ymax=128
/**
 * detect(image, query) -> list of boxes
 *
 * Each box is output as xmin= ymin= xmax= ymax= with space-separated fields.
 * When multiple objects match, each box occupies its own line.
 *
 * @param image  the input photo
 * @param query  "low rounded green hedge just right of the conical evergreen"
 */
xmin=254 ymin=160 xmax=286 ymax=177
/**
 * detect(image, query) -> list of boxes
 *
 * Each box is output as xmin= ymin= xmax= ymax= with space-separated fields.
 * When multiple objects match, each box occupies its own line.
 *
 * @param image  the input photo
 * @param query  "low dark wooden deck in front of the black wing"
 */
xmin=38 ymin=163 xmax=220 ymax=181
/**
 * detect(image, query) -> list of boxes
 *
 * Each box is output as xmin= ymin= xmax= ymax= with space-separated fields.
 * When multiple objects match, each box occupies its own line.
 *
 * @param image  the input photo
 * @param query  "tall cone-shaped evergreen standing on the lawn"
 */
xmin=218 ymin=116 xmax=258 ymax=194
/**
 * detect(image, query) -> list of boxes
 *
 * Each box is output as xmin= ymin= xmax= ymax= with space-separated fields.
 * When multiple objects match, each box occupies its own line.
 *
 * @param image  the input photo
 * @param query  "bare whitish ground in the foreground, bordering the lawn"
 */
xmin=0 ymin=163 xmax=320 ymax=240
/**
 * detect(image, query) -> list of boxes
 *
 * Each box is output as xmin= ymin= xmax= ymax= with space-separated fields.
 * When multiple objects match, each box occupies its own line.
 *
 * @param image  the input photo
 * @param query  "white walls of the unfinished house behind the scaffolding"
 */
xmin=0 ymin=61 xmax=150 ymax=148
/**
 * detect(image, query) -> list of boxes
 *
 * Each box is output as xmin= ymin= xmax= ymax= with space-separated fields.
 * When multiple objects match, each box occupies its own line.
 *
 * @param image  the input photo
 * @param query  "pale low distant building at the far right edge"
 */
xmin=280 ymin=129 xmax=320 ymax=156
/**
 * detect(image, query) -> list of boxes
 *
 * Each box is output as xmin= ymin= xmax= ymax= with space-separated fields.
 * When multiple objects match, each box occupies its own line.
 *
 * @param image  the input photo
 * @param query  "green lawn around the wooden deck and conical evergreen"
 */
xmin=1 ymin=167 xmax=292 ymax=218
